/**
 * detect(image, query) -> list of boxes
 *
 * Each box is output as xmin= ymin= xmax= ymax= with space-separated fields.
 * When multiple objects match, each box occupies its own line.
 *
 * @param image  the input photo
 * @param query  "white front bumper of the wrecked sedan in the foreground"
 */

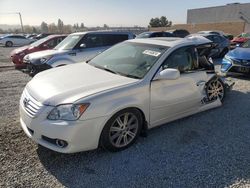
xmin=20 ymin=102 xmax=107 ymax=153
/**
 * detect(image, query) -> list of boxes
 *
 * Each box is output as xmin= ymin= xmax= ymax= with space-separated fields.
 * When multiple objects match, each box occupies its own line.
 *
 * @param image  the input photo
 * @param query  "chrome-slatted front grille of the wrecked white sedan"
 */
xmin=21 ymin=90 xmax=43 ymax=118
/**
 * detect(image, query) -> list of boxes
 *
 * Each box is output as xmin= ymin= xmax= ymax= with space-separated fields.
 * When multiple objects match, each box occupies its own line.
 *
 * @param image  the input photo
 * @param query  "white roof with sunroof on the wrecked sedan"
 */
xmin=128 ymin=36 xmax=212 ymax=47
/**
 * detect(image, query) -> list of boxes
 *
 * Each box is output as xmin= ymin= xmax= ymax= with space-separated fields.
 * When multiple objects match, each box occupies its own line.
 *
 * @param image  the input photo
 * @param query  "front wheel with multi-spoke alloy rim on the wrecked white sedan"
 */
xmin=100 ymin=108 xmax=143 ymax=152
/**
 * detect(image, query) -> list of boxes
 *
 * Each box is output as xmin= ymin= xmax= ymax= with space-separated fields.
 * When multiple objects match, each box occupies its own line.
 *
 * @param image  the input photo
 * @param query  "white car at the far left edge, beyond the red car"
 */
xmin=0 ymin=35 xmax=35 ymax=47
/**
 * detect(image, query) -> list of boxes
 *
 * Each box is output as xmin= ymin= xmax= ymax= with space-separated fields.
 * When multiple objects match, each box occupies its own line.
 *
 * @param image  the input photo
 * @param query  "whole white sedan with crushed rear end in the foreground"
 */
xmin=20 ymin=37 xmax=232 ymax=153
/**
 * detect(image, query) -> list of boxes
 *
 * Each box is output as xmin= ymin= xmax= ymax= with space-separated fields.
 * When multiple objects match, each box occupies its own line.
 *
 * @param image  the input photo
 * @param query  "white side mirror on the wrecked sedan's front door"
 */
xmin=154 ymin=68 xmax=180 ymax=80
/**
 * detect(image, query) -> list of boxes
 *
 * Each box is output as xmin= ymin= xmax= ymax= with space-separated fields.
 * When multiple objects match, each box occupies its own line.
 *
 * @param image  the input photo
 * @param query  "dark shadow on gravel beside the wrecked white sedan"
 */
xmin=37 ymin=91 xmax=250 ymax=187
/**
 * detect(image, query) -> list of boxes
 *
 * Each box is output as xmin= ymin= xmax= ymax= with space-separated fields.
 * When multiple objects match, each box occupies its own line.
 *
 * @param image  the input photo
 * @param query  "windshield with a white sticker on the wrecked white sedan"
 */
xmin=89 ymin=42 xmax=168 ymax=79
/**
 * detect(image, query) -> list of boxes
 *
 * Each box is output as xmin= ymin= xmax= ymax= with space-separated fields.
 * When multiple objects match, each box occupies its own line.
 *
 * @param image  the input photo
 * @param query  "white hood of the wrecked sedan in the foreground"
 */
xmin=26 ymin=63 xmax=138 ymax=106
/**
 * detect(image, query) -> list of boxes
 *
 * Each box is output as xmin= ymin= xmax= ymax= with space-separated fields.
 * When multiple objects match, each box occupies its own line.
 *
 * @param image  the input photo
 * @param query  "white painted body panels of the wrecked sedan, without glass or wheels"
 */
xmin=20 ymin=37 xmax=221 ymax=153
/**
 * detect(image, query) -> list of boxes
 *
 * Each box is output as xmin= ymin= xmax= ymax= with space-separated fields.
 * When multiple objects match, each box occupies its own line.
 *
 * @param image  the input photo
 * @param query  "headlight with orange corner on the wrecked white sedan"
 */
xmin=47 ymin=103 xmax=89 ymax=121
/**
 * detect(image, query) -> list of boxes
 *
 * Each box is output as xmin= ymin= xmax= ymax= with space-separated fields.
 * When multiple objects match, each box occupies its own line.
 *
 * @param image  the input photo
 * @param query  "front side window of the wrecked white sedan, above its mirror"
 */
xmin=162 ymin=47 xmax=195 ymax=73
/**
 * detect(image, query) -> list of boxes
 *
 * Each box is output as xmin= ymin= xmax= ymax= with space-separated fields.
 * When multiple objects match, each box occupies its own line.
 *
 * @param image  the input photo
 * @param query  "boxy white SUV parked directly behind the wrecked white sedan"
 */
xmin=24 ymin=31 xmax=134 ymax=76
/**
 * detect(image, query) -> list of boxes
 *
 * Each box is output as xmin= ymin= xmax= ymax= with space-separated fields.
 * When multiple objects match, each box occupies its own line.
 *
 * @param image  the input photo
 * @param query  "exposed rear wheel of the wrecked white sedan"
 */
xmin=206 ymin=77 xmax=226 ymax=102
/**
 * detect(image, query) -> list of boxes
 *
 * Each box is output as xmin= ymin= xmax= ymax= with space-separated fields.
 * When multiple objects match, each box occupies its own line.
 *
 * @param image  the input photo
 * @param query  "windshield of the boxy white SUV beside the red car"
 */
xmin=54 ymin=35 xmax=82 ymax=50
